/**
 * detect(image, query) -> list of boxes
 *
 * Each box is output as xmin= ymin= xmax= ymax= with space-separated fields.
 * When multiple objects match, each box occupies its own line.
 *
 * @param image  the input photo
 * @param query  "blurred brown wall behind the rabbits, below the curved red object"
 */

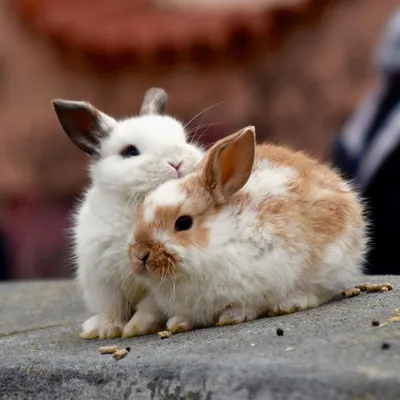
xmin=0 ymin=0 xmax=398 ymax=277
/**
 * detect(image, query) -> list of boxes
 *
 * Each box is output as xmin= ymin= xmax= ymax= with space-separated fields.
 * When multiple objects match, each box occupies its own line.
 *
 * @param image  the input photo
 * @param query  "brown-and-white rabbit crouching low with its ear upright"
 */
xmin=127 ymin=126 xmax=368 ymax=332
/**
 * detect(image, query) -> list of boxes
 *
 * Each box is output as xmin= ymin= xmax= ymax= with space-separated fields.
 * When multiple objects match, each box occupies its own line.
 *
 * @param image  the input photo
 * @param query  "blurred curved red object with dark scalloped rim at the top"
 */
xmin=12 ymin=0 xmax=318 ymax=67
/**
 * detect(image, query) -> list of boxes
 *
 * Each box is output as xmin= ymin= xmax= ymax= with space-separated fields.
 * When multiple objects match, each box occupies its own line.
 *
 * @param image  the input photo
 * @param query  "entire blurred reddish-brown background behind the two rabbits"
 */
xmin=0 ymin=0 xmax=400 ymax=279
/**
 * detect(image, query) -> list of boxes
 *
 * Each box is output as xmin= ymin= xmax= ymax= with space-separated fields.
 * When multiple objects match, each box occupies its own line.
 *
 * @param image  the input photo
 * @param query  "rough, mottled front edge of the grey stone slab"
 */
xmin=0 ymin=356 xmax=400 ymax=400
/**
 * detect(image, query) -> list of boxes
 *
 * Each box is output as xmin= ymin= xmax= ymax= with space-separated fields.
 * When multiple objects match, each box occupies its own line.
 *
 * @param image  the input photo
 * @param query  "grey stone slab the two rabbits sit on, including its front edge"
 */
xmin=0 ymin=277 xmax=400 ymax=400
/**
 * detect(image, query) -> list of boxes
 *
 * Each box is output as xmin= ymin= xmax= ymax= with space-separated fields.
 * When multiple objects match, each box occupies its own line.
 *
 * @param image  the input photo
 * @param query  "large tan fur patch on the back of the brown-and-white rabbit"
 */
xmin=256 ymin=145 xmax=362 ymax=268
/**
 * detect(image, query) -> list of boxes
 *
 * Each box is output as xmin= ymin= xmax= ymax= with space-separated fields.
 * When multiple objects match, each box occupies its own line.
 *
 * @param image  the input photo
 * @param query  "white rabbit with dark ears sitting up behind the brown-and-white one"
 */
xmin=52 ymin=88 xmax=204 ymax=339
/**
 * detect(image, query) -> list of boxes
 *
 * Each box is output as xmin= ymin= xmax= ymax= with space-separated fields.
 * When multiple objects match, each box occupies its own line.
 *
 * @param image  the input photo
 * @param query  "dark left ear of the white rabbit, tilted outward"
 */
xmin=52 ymin=99 xmax=117 ymax=157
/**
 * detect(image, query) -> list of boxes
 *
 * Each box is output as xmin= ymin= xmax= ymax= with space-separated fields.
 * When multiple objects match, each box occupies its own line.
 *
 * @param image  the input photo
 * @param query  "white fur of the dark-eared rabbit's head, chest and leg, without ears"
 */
xmin=74 ymin=111 xmax=202 ymax=337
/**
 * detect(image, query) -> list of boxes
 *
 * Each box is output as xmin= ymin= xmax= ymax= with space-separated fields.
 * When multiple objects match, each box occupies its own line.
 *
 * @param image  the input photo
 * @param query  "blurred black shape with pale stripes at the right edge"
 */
xmin=334 ymin=9 xmax=400 ymax=275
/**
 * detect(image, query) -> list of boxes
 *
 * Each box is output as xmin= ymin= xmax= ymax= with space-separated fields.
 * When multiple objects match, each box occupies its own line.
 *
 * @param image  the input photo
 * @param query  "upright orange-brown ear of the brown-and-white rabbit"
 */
xmin=203 ymin=126 xmax=255 ymax=204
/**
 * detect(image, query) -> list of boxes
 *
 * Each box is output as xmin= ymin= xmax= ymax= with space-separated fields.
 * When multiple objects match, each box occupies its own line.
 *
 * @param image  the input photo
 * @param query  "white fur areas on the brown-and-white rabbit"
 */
xmin=134 ymin=152 xmax=366 ymax=330
